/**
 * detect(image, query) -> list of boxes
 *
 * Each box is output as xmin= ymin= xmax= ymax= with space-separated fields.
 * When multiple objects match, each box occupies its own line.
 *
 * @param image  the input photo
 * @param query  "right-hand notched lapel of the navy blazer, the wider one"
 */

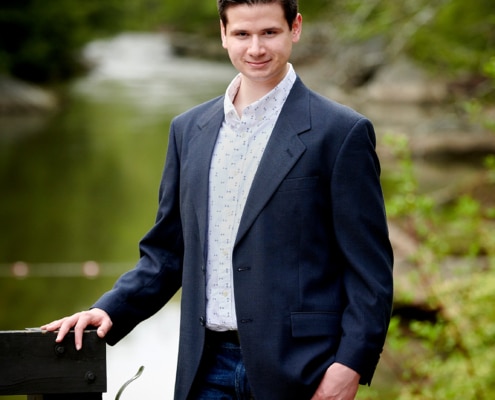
xmin=236 ymin=78 xmax=311 ymax=244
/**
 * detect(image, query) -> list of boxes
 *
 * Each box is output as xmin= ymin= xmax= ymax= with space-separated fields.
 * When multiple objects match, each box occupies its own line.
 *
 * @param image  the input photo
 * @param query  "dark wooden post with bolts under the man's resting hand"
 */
xmin=0 ymin=330 xmax=107 ymax=400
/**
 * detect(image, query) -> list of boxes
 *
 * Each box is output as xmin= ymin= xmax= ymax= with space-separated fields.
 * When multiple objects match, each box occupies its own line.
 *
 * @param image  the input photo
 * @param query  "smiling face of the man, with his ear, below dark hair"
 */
xmin=221 ymin=3 xmax=302 ymax=87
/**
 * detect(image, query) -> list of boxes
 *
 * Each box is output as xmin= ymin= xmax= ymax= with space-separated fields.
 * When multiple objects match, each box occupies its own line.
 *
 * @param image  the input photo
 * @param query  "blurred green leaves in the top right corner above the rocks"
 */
xmin=325 ymin=0 xmax=495 ymax=74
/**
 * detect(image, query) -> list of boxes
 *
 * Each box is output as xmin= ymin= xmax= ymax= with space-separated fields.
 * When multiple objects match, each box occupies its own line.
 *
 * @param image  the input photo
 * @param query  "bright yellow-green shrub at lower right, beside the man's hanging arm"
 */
xmin=387 ymin=57 xmax=495 ymax=400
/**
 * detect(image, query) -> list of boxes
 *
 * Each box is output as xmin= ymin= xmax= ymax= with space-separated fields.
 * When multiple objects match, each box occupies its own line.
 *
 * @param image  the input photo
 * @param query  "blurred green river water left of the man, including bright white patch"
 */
xmin=0 ymin=34 xmax=234 ymax=400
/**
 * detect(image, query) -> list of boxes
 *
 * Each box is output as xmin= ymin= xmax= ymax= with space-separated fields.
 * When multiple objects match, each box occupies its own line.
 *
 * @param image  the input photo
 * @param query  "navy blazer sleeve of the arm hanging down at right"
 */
xmin=332 ymin=118 xmax=393 ymax=384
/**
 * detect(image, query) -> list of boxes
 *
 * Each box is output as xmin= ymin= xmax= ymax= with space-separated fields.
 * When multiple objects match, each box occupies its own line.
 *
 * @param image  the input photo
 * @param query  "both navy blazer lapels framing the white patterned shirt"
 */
xmin=191 ymin=77 xmax=311 ymax=249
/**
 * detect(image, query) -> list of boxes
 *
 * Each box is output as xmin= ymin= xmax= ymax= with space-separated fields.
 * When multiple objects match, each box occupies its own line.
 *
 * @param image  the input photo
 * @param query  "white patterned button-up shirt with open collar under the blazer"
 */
xmin=206 ymin=65 xmax=296 ymax=331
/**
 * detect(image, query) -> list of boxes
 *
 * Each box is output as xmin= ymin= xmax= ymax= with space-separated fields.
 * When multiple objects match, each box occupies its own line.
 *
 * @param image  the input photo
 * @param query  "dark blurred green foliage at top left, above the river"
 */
xmin=0 ymin=0 xmax=223 ymax=82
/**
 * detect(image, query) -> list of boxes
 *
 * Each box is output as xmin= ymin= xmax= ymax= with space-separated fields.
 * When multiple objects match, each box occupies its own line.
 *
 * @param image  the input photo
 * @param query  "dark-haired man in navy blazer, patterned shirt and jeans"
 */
xmin=42 ymin=0 xmax=393 ymax=400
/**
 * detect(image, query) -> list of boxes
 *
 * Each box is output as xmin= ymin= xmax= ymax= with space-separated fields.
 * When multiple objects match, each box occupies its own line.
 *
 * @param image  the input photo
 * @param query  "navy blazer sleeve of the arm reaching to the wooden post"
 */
xmin=93 ymin=119 xmax=184 ymax=345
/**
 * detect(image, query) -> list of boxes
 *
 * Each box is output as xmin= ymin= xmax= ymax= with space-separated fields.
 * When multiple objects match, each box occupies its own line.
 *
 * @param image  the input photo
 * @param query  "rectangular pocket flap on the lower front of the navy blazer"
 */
xmin=291 ymin=312 xmax=340 ymax=337
